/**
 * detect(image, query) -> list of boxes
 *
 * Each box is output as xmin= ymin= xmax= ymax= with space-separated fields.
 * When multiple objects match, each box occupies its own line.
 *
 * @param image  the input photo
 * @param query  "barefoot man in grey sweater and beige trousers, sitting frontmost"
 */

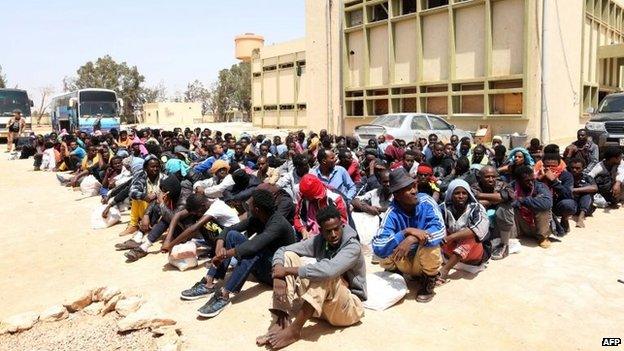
xmin=256 ymin=206 xmax=366 ymax=349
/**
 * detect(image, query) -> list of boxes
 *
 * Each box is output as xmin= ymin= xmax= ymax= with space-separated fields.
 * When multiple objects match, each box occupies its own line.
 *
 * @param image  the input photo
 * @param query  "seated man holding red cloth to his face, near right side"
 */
xmin=535 ymin=153 xmax=576 ymax=236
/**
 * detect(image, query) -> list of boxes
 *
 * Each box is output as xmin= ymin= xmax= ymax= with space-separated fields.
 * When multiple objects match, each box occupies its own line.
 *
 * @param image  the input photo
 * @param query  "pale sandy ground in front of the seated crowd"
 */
xmin=0 ymin=155 xmax=624 ymax=350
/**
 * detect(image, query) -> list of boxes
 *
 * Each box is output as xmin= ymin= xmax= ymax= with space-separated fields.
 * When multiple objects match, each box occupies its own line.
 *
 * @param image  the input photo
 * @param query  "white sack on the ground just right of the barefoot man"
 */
xmin=363 ymin=271 xmax=407 ymax=311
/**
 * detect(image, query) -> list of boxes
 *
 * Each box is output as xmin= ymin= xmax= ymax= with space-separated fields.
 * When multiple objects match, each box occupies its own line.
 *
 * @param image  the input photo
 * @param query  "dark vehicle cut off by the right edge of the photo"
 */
xmin=585 ymin=93 xmax=624 ymax=147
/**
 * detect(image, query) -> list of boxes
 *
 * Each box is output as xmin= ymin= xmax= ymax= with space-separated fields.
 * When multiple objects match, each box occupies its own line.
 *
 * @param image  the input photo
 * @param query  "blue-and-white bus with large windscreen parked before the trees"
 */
xmin=50 ymin=89 xmax=123 ymax=133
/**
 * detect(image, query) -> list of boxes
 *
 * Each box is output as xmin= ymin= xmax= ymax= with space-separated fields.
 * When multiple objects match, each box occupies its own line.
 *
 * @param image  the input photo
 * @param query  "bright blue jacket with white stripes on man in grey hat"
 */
xmin=372 ymin=193 xmax=446 ymax=258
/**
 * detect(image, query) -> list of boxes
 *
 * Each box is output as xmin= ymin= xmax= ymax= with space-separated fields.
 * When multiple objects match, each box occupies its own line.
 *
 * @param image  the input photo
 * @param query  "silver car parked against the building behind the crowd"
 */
xmin=353 ymin=113 xmax=472 ymax=145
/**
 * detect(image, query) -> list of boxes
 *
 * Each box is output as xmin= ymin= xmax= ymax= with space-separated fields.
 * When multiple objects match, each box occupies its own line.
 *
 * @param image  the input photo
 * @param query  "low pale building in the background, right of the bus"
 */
xmin=141 ymin=102 xmax=204 ymax=126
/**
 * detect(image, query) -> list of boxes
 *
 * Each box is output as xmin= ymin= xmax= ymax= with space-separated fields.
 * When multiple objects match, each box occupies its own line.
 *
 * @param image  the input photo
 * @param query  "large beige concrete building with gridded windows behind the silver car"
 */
xmin=246 ymin=0 xmax=624 ymax=142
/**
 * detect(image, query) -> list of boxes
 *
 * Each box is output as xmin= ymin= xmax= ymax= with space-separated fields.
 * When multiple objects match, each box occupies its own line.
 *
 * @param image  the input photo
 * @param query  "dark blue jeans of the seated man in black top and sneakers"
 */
xmin=208 ymin=230 xmax=275 ymax=293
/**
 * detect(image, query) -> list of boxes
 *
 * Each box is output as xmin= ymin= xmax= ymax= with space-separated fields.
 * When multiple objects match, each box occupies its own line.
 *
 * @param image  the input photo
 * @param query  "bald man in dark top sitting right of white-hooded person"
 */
xmin=471 ymin=165 xmax=517 ymax=260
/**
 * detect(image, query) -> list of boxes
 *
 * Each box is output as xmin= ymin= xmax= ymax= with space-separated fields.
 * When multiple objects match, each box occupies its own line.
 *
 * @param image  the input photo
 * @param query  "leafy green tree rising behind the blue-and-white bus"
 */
xmin=63 ymin=55 xmax=145 ymax=117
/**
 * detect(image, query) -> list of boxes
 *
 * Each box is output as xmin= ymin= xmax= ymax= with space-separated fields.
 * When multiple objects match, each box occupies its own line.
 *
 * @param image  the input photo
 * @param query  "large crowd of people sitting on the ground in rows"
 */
xmin=15 ymin=128 xmax=624 ymax=348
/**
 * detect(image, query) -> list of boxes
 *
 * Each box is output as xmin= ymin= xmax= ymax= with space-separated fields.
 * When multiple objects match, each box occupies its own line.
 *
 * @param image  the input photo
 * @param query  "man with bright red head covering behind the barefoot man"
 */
xmin=295 ymin=174 xmax=348 ymax=239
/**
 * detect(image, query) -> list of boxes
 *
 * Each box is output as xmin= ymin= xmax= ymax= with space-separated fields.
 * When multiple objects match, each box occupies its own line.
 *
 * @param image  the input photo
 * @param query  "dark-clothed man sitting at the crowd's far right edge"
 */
xmin=588 ymin=146 xmax=624 ymax=207
